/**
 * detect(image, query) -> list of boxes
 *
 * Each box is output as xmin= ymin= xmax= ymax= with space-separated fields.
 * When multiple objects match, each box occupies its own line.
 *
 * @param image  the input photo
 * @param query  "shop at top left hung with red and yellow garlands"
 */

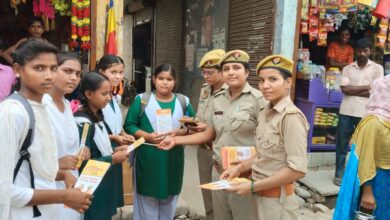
xmin=0 ymin=0 xmax=91 ymax=68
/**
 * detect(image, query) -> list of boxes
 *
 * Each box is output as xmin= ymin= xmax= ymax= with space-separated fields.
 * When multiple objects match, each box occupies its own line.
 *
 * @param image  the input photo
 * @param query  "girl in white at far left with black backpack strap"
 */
xmin=0 ymin=39 xmax=91 ymax=220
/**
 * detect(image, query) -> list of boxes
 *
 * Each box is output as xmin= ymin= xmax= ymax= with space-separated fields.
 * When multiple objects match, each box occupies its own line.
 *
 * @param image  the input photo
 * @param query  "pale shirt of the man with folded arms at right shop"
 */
xmin=340 ymin=60 xmax=384 ymax=118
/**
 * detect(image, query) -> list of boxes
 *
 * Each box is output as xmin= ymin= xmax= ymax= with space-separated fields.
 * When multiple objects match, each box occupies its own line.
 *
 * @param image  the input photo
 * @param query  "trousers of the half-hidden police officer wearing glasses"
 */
xmin=197 ymin=147 xmax=214 ymax=220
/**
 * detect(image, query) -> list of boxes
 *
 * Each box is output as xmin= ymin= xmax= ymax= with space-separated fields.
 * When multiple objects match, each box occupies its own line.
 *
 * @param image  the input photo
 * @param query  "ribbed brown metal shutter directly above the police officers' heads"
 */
xmin=227 ymin=0 xmax=274 ymax=88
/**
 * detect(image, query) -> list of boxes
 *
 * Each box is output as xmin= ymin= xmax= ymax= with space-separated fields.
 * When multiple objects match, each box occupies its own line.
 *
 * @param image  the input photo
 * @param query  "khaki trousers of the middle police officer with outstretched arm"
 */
xmin=212 ymin=168 xmax=251 ymax=220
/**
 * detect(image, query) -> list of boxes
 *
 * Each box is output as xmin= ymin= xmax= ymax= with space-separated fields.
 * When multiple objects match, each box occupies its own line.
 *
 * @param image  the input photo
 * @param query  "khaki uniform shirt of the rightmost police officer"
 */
xmin=252 ymin=96 xmax=309 ymax=180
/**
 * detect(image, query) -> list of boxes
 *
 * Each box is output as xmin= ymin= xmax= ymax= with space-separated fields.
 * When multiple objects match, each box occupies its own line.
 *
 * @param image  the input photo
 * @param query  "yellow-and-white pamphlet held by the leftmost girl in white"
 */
xmin=75 ymin=160 xmax=110 ymax=194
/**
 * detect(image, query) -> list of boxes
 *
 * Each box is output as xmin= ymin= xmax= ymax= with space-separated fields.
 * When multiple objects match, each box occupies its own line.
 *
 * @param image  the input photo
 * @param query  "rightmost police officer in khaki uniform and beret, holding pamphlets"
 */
xmin=221 ymin=55 xmax=309 ymax=220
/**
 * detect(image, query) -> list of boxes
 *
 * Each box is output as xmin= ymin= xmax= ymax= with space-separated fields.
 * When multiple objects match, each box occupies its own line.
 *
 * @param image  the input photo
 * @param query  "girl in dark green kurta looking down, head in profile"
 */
xmin=75 ymin=72 xmax=128 ymax=220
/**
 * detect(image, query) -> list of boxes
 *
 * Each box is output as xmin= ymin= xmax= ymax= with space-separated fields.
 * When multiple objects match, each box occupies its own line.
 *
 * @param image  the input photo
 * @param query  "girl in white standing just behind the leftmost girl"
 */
xmin=43 ymin=52 xmax=89 ymax=220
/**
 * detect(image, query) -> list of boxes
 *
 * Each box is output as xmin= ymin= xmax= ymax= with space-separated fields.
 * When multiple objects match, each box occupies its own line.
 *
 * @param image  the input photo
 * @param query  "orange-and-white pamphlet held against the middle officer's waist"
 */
xmin=221 ymin=146 xmax=256 ymax=170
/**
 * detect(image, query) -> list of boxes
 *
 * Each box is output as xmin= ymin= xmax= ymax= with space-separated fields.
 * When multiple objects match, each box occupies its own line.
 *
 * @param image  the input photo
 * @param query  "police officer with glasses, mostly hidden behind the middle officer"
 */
xmin=196 ymin=49 xmax=228 ymax=220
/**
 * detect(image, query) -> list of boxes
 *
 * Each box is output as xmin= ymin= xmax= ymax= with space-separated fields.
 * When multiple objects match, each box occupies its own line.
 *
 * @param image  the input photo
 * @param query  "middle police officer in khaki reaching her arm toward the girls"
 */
xmin=160 ymin=50 xmax=267 ymax=220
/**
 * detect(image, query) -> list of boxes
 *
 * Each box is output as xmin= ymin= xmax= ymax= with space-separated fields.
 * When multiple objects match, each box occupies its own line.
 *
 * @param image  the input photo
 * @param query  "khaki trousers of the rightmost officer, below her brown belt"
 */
xmin=251 ymin=194 xmax=299 ymax=220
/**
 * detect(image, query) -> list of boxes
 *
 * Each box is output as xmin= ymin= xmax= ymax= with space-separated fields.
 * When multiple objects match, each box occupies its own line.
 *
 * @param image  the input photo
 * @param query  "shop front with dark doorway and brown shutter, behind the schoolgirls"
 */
xmin=123 ymin=0 xmax=184 ymax=93
